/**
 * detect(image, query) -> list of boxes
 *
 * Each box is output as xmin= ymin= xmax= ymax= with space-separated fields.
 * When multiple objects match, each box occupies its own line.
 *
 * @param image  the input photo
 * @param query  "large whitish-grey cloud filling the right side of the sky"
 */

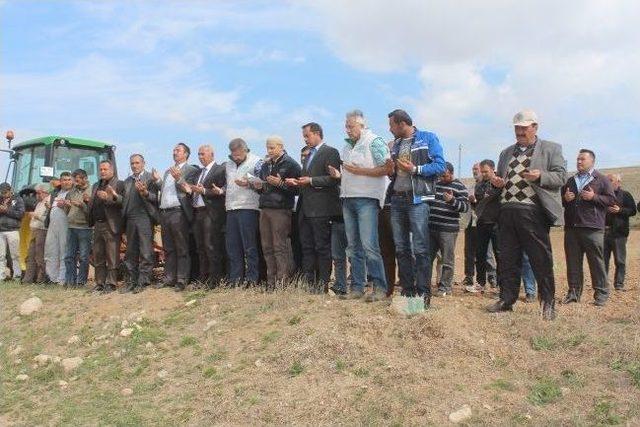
xmin=312 ymin=0 xmax=640 ymax=171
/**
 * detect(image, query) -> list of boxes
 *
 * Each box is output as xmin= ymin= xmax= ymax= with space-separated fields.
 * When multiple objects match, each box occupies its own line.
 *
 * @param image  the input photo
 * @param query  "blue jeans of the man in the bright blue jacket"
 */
xmin=391 ymin=196 xmax=431 ymax=296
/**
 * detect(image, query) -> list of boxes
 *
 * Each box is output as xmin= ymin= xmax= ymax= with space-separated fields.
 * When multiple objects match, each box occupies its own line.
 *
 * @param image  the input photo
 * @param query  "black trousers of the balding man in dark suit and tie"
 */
xmin=193 ymin=206 xmax=226 ymax=284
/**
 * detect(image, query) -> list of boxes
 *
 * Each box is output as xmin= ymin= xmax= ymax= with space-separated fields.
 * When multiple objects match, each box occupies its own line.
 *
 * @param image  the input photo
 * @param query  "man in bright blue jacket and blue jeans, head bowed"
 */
xmin=387 ymin=110 xmax=445 ymax=308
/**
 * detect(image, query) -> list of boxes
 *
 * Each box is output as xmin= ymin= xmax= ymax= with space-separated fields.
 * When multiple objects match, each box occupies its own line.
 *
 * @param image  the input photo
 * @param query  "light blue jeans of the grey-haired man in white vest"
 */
xmin=342 ymin=197 xmax=387 ymax=293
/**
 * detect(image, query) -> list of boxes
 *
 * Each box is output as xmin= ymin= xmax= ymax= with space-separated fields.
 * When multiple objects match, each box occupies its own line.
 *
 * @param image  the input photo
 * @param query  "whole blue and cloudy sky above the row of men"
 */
xmin=0 ymin=0 xmax=640 ymax=176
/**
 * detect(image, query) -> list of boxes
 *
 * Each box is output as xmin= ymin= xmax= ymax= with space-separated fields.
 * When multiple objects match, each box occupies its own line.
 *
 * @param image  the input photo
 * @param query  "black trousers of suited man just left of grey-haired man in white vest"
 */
xmin=300 ymin=214 xmax=332 ymax=291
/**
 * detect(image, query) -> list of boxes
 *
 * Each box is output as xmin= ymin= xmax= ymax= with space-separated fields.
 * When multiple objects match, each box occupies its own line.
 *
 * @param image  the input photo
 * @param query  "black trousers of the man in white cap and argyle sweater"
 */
xmin=498 ymin=204 xmax=556 ymax=305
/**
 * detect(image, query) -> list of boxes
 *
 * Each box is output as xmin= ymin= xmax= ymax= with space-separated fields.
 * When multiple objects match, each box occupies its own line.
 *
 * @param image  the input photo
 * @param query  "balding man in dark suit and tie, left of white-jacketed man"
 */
xmin=183 ymin=145 xmax=227 ymax=288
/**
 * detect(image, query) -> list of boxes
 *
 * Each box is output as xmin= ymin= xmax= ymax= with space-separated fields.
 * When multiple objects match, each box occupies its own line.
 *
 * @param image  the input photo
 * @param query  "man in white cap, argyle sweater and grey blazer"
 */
xmin=488 ymin=110 xmax=567 ymax=320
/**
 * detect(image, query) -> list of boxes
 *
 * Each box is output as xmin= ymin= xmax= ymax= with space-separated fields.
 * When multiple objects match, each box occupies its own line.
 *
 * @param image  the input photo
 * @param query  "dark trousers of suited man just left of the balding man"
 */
xmin=160 ymin=208 xmax=191 ymax=285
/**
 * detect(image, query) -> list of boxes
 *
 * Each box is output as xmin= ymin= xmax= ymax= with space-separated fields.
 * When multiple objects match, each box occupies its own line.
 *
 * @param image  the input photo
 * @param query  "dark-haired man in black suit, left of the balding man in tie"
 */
xmin=153 ymin=142 xmax=198 ymax=292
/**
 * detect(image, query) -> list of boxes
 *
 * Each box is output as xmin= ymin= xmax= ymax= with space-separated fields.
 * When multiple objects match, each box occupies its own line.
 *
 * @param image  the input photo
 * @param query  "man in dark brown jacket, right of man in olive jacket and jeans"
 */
xmin=89 ymin=160 xmax=124 ymax=293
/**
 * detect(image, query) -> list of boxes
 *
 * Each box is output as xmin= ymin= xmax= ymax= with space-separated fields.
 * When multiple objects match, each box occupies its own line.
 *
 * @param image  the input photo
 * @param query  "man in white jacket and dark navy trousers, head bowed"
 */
xmin=225 ymin=138 xmax=262 ymax=285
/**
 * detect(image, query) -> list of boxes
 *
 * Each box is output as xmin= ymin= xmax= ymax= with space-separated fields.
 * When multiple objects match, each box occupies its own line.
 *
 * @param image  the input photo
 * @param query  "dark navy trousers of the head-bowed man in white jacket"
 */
xmin=226 ymin=209 xmax=260 ymax=284
